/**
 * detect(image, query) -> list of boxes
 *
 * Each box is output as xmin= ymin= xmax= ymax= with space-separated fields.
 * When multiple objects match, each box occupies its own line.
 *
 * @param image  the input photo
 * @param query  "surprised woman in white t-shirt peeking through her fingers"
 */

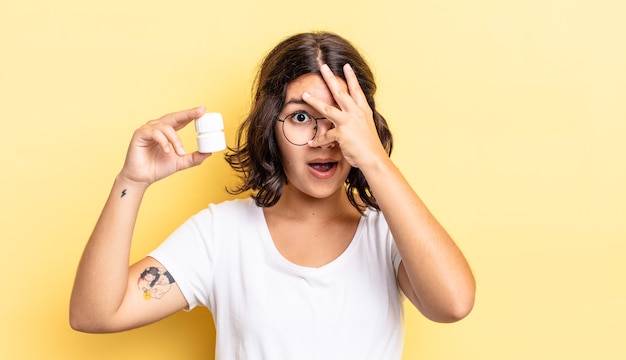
xmin=70 ymin=33 xmax=475 ymax=359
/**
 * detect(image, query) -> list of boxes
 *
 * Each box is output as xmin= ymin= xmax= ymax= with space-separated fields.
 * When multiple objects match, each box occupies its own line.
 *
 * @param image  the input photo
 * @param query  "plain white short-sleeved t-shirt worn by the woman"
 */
xmin=150 ymin=199 xmax=404 ymax=360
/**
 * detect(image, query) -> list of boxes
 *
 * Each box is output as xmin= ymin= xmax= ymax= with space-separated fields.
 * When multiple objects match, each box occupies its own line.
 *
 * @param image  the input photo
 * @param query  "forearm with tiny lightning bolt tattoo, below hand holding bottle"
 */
xmin=70 ymin=176 xmax=146 ymax=328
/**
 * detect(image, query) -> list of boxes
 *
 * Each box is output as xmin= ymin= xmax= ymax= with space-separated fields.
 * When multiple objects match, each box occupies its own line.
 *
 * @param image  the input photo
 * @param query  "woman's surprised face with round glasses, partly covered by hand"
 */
xmin=275 ymin=74 xmax=351 ymax=199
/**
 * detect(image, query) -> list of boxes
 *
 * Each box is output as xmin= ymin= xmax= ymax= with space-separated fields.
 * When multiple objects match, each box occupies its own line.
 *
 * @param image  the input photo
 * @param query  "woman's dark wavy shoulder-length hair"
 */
xmin=225 ymin=32 xmax=393 ymax=212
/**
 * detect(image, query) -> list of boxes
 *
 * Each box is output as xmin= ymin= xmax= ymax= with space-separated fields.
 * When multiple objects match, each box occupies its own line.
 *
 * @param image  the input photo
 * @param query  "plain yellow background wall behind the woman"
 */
xmin=0 ymin=0 xmax=626 ymax=360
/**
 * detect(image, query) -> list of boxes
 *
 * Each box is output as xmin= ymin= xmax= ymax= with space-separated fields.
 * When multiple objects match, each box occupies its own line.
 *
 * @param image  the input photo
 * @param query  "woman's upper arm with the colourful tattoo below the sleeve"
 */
xmin=112 ymin=257 xmax=188 ymax=331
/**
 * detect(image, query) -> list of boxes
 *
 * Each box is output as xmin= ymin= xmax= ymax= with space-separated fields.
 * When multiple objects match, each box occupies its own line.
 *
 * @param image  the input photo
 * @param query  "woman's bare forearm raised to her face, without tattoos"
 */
xmin=364 ymin=158 xmax=475 ymax=321
